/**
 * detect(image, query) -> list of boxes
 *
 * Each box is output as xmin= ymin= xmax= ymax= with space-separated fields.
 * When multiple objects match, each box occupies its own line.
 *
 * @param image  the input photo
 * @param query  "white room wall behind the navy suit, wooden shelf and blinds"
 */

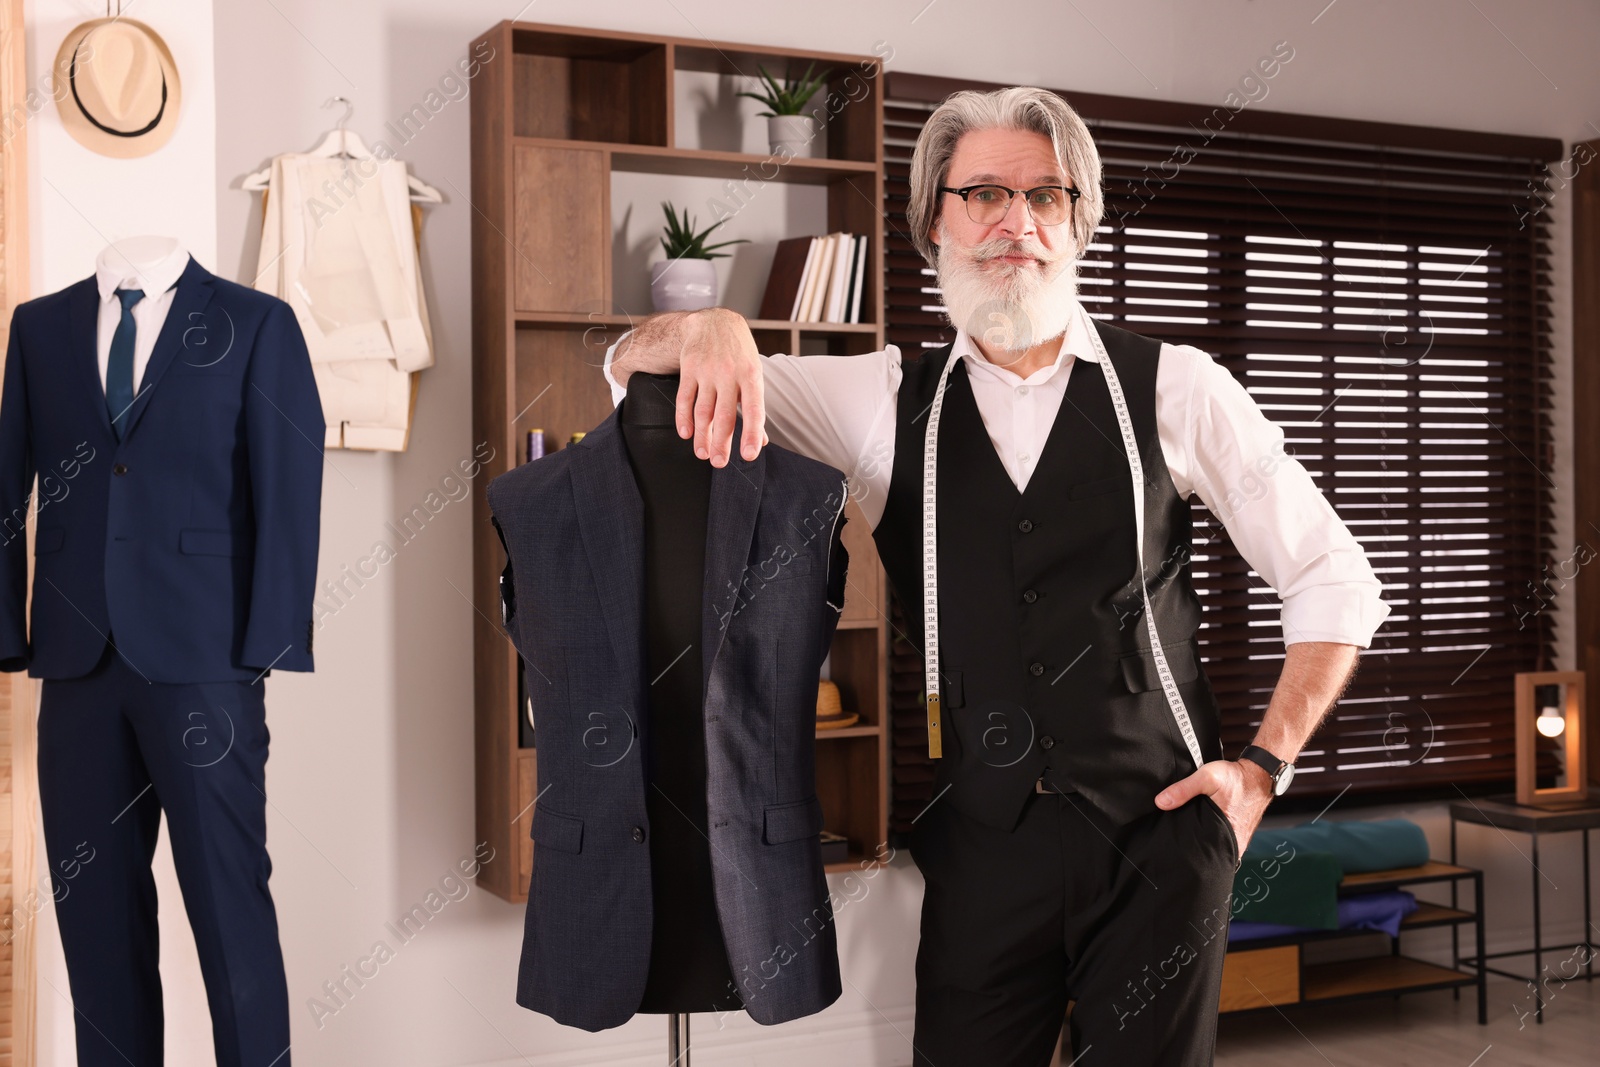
xmin=15 ymin=0 xmax=1600 ymax=1067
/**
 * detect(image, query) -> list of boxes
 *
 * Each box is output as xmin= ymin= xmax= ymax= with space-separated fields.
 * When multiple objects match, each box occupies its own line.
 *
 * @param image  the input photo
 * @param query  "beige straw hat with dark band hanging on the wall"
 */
xmin=56 ymin=16 xmax=181 ymax=158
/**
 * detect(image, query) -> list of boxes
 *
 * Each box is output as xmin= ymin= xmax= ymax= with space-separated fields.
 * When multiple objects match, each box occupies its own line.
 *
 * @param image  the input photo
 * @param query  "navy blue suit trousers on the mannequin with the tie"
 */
xmin=38 ymin=645 xmax=290 ymax=1067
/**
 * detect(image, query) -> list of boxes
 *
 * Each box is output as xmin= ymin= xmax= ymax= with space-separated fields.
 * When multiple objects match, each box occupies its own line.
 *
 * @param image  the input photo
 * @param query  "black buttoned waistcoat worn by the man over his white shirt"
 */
xmin=874 ymin=322 xmax=1222 ymax=830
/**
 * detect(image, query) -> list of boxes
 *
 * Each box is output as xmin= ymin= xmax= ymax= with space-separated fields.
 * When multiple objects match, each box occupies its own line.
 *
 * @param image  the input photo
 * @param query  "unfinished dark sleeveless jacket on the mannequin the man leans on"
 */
xmin=488 ymin=411 xmax=851 ymax=1030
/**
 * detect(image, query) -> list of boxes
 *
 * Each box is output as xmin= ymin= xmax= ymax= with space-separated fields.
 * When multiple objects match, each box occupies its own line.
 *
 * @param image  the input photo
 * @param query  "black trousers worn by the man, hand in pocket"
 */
xmin=910 ymin=780 xmax=1238 ymax=1067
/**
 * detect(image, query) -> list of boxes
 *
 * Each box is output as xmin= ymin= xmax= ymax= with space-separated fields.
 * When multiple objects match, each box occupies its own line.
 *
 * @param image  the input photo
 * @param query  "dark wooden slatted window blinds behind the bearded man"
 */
xmin=883 ymin=74 xmax=1555 ymax=830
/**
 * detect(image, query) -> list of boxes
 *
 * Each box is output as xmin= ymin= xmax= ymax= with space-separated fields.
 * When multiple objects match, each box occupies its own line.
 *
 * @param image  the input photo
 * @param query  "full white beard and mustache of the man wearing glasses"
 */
xmin=936 ymin=219 xmax=1078 ymax=365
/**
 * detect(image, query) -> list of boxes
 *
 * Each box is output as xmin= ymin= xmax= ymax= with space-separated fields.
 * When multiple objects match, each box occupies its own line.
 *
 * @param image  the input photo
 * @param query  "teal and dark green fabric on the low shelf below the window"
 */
xmin=1232 ymin=819 xmax=1429 ymax=929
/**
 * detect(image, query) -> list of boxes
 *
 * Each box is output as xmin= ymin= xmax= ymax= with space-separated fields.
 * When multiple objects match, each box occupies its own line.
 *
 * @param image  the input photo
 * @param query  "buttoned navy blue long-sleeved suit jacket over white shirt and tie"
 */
xmin=0 ymin=259 xmax=323 ymax=683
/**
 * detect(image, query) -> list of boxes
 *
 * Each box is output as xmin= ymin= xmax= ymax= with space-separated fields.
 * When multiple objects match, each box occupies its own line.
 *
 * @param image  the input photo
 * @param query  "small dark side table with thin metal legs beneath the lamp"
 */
xmin=1450 ymin=793 xmax=1600 ymax=1024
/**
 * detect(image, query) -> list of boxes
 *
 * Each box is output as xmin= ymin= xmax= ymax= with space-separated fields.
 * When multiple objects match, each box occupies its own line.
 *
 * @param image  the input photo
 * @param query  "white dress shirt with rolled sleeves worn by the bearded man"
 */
xmin=605 ymin=306 xmax=1389 ymax=648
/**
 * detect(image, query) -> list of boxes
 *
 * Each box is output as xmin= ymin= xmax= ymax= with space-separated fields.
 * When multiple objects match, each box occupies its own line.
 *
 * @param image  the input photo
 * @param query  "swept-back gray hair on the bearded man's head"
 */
xmin=906 ymin=86 xmax=1106 ymax=266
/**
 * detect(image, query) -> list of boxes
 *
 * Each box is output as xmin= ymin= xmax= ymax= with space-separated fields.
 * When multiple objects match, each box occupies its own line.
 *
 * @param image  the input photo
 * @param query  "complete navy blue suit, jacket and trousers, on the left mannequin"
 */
xmin=0 ymin=259 xmax=323 ymax=1067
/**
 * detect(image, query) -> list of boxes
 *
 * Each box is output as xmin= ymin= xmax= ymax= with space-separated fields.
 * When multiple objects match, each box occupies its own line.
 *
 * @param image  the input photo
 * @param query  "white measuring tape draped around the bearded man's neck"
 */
xmin=922 ymin=306 xmax=1205 ymax=769
